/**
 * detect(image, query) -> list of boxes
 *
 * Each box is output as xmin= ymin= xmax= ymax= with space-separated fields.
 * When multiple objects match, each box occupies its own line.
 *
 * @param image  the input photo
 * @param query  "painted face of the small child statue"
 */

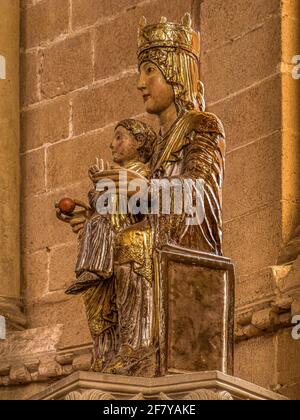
xmin=110 ymin=127 xmax=140 ymax=166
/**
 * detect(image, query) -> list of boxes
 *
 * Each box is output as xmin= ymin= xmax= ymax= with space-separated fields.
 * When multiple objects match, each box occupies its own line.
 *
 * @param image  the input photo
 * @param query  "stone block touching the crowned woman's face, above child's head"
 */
xmin=73 ymin=75 xmax=144 ymax=135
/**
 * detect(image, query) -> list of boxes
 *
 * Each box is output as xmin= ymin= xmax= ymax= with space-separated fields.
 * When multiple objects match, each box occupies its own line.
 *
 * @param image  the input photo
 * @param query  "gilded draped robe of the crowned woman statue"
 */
xmin=111 ymin=111 xmax=225 ymax=376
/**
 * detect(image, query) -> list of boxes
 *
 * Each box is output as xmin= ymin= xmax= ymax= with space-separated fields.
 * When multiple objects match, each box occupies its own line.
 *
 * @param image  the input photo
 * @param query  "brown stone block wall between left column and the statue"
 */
xmin=21 ymin=0 xmax=196 ymax=348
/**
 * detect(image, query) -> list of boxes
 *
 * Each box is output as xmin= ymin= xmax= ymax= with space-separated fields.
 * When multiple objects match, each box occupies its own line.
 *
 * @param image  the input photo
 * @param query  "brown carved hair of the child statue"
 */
xmin=115 ymin=119 xmax=157 ymax=163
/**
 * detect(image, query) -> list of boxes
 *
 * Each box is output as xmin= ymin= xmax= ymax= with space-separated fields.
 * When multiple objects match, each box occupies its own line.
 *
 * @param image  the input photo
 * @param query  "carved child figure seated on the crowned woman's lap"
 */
xmin=66 ymin=119 xmax=156 ymax=294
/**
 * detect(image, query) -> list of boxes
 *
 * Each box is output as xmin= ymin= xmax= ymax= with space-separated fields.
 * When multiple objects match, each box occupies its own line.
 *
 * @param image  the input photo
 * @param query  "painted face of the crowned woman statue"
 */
xmin=138 ymin=61 xmax=175 ymax=115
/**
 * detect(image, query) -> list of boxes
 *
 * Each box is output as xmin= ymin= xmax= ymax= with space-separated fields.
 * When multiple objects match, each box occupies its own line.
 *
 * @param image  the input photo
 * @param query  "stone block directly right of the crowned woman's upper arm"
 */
xmin=223 ymin=133 xmax=282 ymax=220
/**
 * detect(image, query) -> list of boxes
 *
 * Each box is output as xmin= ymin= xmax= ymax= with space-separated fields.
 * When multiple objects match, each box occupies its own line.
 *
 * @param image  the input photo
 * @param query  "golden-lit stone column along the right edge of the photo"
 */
xmin=277 ymin=0 xmax=300 ymax=264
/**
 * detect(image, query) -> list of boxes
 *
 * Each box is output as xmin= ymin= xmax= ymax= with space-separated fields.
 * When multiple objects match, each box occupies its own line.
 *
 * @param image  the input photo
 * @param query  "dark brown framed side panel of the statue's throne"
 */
xmin=157 ymin=247 xmax=234 ymax=375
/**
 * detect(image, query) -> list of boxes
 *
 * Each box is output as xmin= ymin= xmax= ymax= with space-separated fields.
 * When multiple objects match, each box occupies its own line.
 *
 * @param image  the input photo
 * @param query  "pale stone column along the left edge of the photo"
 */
xmin=0 ymin=0 xmax=25 ymax=329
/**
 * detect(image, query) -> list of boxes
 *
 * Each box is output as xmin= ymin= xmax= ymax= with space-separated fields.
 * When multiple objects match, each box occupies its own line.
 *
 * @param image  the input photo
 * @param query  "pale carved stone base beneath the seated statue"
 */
xmin=30 ymin=371 xmax=287 ymax=401
